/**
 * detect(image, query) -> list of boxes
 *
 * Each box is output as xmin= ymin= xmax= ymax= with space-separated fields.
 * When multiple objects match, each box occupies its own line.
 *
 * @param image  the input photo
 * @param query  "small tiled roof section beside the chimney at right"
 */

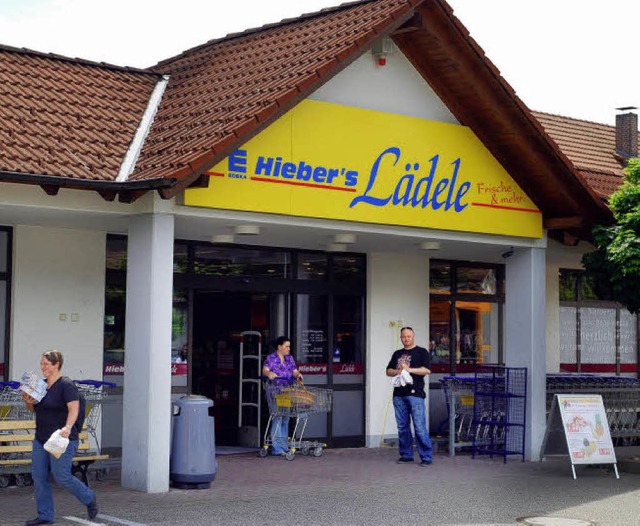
xmin=533 ymin=112 xmax=625 ymax=198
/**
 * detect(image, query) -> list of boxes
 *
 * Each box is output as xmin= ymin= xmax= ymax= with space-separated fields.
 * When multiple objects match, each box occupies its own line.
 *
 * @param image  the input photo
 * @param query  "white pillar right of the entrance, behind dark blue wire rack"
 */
xmin=505 ymin=248 xmax=547 ymax=460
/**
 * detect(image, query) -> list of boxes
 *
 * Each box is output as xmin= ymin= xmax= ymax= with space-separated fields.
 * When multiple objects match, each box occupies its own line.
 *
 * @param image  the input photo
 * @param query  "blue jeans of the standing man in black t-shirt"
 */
xmin=393 ymin=396 xmax=433 ymax=462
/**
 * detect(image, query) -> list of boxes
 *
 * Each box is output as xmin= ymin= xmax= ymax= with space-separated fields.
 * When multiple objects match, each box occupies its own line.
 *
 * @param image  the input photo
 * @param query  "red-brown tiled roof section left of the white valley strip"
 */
xmin=0 ymin=46 xmax=158 ymax=181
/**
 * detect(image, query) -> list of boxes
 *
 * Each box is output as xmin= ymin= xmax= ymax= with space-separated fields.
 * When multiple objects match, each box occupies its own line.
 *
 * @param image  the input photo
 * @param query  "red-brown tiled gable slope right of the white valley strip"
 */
xmin=131 ymin=0 xmax=419 ymax=185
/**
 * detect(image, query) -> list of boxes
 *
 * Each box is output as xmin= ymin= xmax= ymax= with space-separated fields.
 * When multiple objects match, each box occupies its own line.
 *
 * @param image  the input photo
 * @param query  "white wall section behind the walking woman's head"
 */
xmin=9 ymin=226 xmax=106 ymax=380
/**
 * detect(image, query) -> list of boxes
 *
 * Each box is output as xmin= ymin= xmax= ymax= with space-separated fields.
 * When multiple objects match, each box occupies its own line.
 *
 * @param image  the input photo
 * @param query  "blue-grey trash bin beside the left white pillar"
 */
xmin=169 ymin=395 xmax=218 ymax=489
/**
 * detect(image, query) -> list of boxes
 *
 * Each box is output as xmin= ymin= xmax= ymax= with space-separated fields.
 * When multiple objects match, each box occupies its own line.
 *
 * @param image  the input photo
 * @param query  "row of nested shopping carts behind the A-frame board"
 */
xmin=547 ymin=374 xmax=640 ymax=446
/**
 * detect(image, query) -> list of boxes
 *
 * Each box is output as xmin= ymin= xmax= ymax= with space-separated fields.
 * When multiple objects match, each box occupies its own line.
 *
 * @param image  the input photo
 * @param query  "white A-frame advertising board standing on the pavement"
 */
xmin=542 ymin=394 xmax=618 ymax=478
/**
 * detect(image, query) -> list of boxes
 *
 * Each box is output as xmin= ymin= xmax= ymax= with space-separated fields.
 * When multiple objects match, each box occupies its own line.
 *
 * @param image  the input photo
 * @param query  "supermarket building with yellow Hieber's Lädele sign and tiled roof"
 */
xmin=0 ymin=0 xmax=637 ymax=492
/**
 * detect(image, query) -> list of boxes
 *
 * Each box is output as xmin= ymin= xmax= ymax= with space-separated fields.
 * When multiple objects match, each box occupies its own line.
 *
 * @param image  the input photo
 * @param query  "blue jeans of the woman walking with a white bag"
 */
xmin=31 ymin=439 xmax=94 ymax=521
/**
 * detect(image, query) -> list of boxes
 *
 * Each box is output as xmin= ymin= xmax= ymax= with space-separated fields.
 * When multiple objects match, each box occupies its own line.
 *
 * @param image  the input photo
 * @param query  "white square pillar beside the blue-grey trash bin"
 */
xmin=122 ymin=214 xmax=174 ymax=493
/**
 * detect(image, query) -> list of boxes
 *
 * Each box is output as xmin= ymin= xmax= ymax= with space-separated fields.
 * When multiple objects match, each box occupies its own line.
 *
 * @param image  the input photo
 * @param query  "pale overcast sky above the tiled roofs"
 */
xmin=0 ymin=0 xmax=640 ymax=124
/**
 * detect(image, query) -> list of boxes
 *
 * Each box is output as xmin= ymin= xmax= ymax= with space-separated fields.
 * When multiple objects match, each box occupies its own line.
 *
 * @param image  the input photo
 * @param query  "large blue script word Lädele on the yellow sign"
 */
xmin=349 ymin=146 xmax=471 ymax=212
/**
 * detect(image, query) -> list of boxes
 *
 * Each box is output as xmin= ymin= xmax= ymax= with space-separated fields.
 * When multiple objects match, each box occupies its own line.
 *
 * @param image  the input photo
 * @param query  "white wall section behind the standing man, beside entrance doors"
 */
xmin=366 ymin=253 xmax=429 ymax=447
